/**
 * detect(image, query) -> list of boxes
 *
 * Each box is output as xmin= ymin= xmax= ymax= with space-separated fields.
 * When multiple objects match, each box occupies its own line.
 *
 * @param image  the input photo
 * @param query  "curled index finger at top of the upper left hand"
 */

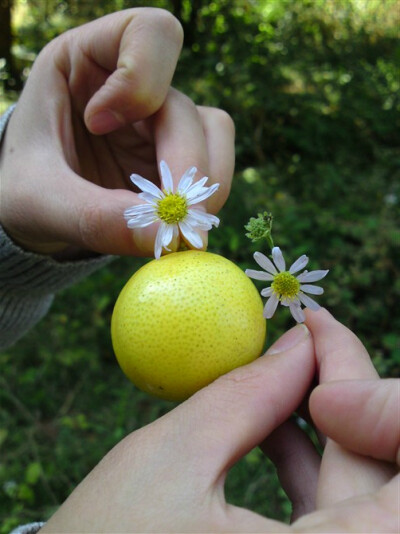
xmin=66 ymin=8 xmax=183 ymax=134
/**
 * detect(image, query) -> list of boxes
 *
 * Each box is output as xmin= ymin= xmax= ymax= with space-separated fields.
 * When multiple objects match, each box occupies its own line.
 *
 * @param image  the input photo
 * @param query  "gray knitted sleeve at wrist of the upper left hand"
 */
xmin=0 ymin=108 xmax=111 ymax=350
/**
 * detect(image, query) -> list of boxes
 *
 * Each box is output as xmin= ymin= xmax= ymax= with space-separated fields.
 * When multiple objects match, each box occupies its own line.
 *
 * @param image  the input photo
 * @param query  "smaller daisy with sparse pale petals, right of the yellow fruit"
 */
xmin=246 ymin=247 xmax=329 ymax=323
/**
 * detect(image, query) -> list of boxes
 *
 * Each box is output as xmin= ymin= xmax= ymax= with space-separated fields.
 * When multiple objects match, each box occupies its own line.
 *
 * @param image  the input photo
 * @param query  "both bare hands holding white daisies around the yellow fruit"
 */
xmin=0 ymin=8 xmax=399 ymax=532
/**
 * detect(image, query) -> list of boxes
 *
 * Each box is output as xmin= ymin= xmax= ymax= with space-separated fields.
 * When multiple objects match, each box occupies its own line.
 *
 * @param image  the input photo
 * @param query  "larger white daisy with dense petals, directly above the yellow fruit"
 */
xmin=124 ymin=161 xmax=219 ymax=259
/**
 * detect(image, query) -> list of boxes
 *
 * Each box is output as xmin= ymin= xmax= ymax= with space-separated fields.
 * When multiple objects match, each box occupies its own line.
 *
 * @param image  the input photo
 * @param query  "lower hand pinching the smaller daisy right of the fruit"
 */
xmin=41 ymin=310 xmax=400 ymax=534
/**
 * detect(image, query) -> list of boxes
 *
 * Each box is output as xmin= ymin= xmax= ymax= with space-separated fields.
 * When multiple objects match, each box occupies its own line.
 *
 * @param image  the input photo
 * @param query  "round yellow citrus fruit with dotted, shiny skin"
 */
xmin=111 ymin=250 xmax=266 ymax=401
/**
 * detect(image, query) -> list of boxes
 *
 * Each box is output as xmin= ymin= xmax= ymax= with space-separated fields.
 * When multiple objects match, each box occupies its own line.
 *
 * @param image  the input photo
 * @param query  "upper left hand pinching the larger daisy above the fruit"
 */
xmin=0 ymin=8 xmax=234 ymax=257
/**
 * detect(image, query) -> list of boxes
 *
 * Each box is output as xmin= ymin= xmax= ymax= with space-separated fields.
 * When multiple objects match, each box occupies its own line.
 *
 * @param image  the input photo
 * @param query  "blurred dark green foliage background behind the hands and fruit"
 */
xmin=0 ymin=0 xmax=400 ymax=533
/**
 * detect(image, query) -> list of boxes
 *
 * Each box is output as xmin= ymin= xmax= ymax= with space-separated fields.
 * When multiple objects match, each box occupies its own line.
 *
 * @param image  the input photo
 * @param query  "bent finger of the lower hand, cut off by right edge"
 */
xmin=310 ymin=379 xmax=400 ymax=465
